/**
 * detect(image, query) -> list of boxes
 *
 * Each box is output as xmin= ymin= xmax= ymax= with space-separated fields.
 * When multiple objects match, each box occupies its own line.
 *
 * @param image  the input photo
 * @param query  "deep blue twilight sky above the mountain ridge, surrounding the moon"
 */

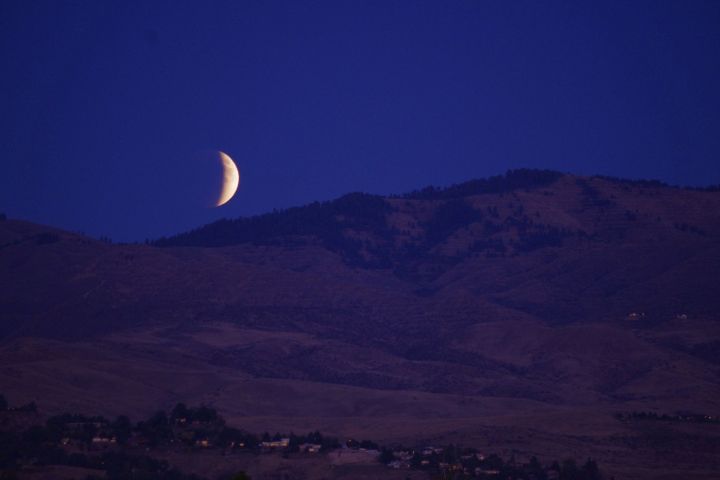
xmin=0 ymin=0 xmax=720 ymax=240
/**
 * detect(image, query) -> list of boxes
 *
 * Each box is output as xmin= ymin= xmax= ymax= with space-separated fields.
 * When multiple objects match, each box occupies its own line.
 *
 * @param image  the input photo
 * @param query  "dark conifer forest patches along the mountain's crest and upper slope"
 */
xmin=151 ymin=169 xmax=580 ymax=276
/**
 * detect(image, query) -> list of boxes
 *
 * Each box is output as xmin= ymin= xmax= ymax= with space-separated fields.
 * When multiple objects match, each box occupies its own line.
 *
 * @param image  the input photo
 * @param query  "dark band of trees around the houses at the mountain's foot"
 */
xmin=0 ymin=395 xmax=602 ymax=480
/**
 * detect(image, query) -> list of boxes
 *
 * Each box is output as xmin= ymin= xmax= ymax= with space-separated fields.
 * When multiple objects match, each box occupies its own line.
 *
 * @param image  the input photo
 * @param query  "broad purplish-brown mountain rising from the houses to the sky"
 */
xmin=0 ymin=170 xmax=720 ymax=478
